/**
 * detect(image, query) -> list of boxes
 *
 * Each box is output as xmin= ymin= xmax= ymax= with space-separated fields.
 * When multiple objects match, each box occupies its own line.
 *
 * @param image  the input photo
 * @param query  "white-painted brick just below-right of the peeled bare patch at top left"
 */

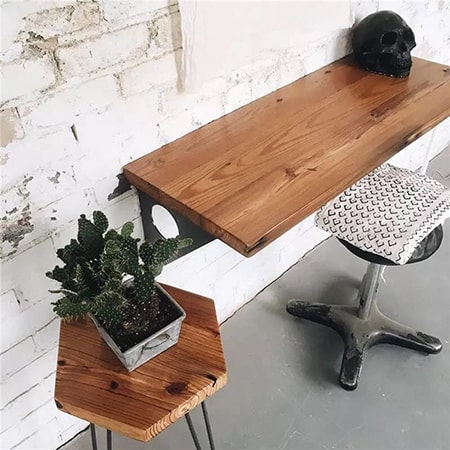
xmin=56 ymin=24 xmax=149 ymax=78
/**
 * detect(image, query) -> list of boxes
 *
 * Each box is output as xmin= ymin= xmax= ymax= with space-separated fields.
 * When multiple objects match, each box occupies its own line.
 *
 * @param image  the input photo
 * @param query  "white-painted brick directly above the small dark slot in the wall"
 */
xmin=18 ymin=75 xmax=117 ymax=130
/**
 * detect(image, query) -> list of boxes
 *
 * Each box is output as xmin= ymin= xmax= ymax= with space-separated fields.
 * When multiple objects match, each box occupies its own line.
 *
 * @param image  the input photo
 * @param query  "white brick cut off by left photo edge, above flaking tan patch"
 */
xmin=0 ymin=56 xmax=56 ymax=102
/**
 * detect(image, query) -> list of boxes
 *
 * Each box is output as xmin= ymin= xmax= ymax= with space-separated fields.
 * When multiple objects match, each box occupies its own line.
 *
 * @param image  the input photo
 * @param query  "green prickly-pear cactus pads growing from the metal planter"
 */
xmin=46 ymin=211 xmax=192 ymax=327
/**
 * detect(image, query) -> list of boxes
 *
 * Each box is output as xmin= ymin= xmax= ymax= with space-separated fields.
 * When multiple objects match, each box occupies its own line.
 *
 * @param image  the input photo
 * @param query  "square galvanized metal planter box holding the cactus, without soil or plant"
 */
xmin=89 ymin=284 xmax=186 ymax=372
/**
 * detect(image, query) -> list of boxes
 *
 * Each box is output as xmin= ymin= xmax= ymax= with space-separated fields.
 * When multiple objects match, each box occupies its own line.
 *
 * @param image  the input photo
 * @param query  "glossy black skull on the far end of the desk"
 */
xmin=352 ymin=11 xmax=416 ymax=78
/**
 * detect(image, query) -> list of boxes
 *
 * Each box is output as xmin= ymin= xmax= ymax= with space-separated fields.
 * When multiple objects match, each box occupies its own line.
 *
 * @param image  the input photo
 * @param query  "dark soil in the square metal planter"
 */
xmin=97 ymin=289 xmax=181 ymax=352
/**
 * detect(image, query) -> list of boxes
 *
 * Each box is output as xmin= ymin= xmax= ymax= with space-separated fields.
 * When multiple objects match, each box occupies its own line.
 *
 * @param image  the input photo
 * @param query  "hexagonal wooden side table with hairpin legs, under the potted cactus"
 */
xmin=55 ymin=286 xmax=227 ymax=450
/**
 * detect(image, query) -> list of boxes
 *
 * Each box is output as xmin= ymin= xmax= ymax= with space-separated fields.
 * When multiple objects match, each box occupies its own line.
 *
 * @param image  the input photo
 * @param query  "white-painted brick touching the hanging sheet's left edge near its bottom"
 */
xmin=120 ymin=52 xmax=179 ymax=97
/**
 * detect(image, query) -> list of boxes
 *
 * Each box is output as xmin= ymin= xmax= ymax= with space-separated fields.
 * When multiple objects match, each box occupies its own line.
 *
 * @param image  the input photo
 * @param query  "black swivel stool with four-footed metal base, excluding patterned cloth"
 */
xmin=287 ymin=225 xmax=443 ymax=391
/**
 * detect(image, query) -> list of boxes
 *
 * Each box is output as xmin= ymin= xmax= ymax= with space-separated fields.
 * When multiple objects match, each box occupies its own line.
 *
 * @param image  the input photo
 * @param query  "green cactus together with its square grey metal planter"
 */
xmin=46 ymin=211 xmax=192 ymax=371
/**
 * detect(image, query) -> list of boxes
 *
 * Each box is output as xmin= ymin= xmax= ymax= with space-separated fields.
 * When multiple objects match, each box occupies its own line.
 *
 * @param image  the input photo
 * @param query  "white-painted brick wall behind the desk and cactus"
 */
xmin=0 ymin=0 xmax=450 ymax=450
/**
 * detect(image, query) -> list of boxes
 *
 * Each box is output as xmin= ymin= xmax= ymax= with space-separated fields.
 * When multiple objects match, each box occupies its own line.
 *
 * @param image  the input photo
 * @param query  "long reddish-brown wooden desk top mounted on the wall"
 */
xmin=124 ymin=57 xmax=450 ymax=256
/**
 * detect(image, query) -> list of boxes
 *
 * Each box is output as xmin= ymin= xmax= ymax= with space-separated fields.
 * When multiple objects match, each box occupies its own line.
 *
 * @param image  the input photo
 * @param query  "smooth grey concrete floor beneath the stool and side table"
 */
xmin=63 ymin=152 xmax=450 ymax=450
